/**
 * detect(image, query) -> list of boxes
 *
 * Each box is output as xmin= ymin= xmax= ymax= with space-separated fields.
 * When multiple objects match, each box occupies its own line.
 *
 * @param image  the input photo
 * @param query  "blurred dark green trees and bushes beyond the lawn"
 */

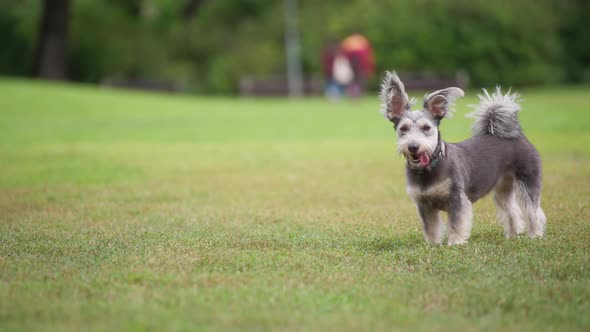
xmin=0 ymin=0 xmax=590 ymax=95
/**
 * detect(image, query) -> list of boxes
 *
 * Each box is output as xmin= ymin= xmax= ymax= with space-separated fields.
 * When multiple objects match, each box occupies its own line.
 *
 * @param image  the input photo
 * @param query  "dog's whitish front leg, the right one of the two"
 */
xmin=449 ymin=191 xmax=473 ymax=246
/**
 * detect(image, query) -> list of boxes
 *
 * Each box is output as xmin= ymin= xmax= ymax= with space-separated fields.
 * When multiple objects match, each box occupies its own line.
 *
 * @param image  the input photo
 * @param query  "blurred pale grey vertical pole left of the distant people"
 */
xmin=284 ymin=0 xmax=303 ymax=97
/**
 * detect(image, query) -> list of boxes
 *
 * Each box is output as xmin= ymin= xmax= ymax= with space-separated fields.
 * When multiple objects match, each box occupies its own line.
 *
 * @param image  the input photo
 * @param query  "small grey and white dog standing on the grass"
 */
xmin=381 ymin=72 xmax=546 ymax=245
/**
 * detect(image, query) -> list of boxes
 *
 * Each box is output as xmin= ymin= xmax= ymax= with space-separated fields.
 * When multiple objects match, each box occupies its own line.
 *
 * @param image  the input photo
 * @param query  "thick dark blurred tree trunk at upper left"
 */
xmin=35 ymin=0 xmax=70 ymax=80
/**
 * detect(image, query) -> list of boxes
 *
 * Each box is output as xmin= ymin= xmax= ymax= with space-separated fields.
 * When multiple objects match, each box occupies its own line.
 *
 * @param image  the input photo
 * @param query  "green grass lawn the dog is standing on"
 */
xmin=0 ymin=80 xmax=590 ymax=331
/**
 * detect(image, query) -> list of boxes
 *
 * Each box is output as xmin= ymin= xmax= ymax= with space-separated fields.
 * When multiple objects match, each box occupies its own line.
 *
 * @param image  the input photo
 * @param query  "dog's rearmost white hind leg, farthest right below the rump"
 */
xmin=516 ymin=172 xmax=547 ymax=238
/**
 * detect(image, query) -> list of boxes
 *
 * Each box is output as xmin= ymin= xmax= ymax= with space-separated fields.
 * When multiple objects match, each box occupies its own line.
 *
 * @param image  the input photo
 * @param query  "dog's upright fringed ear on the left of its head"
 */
xmin=380 ymin=71 xmax=414 ymax=124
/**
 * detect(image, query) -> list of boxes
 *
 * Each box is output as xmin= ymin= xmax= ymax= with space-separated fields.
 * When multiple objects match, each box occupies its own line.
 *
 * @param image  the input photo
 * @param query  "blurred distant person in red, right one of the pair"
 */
xmin=340 ymin=33 xmax=375 ymax=98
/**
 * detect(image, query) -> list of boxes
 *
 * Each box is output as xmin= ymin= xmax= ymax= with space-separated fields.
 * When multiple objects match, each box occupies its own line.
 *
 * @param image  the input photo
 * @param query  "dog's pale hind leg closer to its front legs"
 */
xmin=494 ymin=175 xmax=525 ymax=238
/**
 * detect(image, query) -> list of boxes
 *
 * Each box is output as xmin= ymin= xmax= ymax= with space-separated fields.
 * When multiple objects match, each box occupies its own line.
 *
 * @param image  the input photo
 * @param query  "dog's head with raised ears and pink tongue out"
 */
xmin=381 ymin=71 xmax=463 ymax=170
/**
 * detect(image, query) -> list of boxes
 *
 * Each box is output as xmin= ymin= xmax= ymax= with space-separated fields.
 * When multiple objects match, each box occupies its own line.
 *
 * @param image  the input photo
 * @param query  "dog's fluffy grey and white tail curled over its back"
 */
xmin=467 ymin=87 xmax=522 ymax=138
